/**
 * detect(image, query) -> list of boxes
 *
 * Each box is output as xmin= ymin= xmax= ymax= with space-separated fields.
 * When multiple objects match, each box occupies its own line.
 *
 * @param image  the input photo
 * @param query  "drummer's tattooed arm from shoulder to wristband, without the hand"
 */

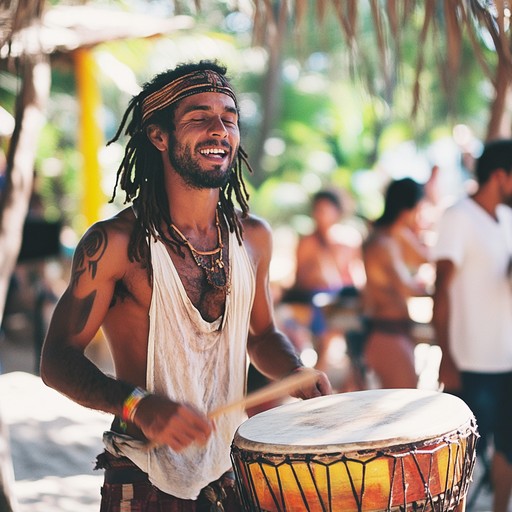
xmin=41 ymin=223 xmax=133 ymax=415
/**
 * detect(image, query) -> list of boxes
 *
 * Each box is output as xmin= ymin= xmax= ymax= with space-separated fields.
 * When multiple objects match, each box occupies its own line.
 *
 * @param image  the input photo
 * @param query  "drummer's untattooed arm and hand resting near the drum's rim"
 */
xmin=245 ymin=214 xmax=332 ymax=398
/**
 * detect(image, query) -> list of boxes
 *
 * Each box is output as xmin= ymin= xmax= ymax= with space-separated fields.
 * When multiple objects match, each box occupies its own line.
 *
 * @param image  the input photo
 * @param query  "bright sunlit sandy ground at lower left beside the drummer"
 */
xmin=0 ymin=372 xmax=109 ymax=512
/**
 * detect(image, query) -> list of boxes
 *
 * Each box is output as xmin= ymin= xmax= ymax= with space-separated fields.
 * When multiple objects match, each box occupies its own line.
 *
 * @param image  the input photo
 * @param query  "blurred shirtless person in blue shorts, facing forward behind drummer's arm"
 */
xmin=283 ymin=190 xmax=364 ymax=369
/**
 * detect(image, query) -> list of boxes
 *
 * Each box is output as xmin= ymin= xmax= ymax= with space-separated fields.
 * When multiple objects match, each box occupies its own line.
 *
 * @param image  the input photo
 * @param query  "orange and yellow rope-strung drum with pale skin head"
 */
xmin=231 ymin=389 xmax=478 ymax=512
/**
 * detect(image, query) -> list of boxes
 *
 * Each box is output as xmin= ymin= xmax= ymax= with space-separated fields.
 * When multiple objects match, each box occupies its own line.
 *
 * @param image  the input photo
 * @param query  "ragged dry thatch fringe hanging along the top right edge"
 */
xmin=248 ymin=0 xmax=512 ymax=108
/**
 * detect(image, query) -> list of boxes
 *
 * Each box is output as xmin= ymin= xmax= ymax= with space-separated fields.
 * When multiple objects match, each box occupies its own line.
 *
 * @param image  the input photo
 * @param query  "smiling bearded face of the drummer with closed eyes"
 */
xmin=169 ymin=92 xmax=240 ymax=188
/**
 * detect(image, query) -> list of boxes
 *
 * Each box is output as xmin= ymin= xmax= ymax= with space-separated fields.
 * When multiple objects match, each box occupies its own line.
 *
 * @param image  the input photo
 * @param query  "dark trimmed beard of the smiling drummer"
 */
xmin=169 ymin=141 xmax=236 ymax=189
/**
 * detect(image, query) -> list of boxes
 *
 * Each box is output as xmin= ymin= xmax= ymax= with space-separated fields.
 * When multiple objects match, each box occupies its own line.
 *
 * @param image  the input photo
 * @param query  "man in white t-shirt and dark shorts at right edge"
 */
xmin=433 ymin=139 xmax=512 ymax=512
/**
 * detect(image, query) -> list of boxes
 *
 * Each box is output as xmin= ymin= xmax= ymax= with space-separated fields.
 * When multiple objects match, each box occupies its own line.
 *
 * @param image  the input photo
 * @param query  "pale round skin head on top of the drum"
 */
xmin=234 ymin=389 xmax=474 ymax=454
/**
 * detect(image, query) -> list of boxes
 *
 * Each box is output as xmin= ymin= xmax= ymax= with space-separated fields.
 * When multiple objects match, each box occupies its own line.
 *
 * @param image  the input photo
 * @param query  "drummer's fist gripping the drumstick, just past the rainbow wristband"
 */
xmin=134 ymin=395 xmax=213 ymax=452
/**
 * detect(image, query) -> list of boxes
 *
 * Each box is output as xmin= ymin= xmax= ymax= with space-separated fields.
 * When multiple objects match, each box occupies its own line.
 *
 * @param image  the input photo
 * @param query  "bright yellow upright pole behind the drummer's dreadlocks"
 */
xmin=75 ymin=48 xmax=105 ymax=232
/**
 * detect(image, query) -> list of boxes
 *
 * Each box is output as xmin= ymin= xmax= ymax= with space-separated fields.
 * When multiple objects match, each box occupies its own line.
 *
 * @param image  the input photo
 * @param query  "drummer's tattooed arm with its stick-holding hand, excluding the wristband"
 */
xmin=41 ymin=223 xmax=212 ymax=451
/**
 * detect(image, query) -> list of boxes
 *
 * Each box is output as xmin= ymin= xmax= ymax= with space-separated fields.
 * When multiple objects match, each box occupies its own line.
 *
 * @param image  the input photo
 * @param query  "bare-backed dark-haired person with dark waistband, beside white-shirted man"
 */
xmin=362 ymin=178 xmax=429 ymax=388
